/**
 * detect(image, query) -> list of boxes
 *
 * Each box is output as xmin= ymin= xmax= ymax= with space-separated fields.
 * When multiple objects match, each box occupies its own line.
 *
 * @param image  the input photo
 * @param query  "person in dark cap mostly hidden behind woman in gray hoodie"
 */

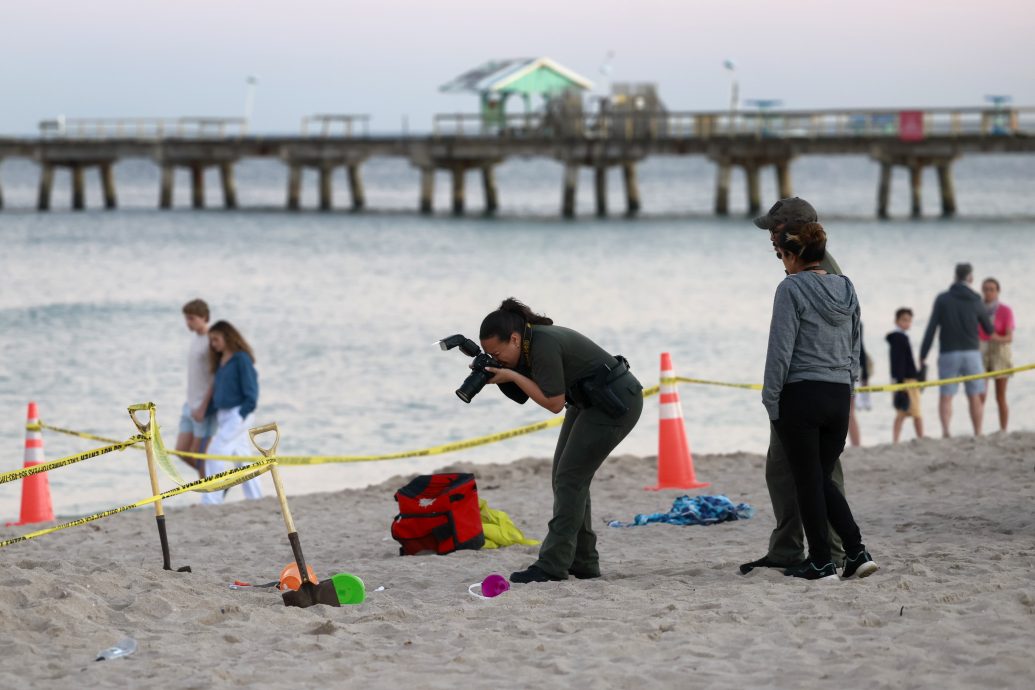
xmin=740 ymin=197 xmax=845 ymax=575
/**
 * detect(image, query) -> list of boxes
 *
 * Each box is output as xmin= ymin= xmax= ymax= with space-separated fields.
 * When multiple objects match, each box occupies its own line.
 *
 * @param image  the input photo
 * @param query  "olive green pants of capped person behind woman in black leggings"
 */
xmin=766 ymin=425 xmax=845 ymax=567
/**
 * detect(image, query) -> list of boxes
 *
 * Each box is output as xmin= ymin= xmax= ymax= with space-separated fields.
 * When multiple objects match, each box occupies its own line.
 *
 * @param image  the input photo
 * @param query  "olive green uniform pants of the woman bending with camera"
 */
xmin=535 ymin=373 xmax=644 ymax=577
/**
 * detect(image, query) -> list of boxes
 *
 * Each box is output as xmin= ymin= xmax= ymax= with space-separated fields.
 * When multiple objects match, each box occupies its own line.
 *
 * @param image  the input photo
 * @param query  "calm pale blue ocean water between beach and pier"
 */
xmin=0 ymin=156 xmax=1035 ymax=517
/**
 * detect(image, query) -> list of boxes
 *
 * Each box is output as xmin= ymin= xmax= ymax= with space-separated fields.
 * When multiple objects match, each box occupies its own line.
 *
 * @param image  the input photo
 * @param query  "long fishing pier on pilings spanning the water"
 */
xmin=0 ymin=108 xmax=1035 ymax=217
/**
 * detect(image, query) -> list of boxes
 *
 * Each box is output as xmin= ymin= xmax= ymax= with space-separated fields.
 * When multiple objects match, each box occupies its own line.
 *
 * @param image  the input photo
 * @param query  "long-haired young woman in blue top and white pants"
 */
xmin=202 ymin=321 xmax=262 ymax=504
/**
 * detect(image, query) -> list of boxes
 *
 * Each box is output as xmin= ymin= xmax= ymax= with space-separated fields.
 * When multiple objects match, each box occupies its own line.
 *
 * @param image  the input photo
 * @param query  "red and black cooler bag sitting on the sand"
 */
xmin=391 ymin=474 xmax=485 ymax=556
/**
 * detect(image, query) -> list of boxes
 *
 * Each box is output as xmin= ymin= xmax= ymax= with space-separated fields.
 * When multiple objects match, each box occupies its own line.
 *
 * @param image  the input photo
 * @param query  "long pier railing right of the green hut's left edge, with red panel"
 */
xmin=432 ymin=108 xmax=1035 ymax=140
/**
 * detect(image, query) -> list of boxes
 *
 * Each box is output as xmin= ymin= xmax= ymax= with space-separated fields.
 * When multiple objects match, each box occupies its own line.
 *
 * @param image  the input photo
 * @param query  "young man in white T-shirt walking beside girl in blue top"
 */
xmin=176 ymin=299 xmax=215 ymax=477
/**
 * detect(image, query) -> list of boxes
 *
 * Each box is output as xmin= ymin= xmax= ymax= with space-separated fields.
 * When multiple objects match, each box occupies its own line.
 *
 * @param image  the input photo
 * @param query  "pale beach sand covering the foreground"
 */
xmin=0 ymin=433 xmax=1035 ymax=690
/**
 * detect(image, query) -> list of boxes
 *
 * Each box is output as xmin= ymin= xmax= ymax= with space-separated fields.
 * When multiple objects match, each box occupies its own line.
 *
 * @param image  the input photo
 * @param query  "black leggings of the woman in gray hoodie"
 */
xmin=775 ymin=381 xmax=862 ymax=565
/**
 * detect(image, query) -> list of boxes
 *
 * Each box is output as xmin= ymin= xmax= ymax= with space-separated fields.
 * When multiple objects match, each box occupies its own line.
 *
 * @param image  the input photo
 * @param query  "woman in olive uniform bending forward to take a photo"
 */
xmin=478 ymin=298 xmax=643 ymax=582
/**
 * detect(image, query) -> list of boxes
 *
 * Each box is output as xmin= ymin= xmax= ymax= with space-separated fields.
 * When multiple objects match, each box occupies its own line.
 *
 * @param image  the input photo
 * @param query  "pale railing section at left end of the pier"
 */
xmin=39 ymin=117 xmax=248 ymax=140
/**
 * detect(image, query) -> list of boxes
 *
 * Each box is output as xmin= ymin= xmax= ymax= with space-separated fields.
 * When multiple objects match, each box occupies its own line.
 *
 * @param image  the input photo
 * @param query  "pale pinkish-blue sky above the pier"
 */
xmin=0 ymin=0 xmax=1035 ymax=136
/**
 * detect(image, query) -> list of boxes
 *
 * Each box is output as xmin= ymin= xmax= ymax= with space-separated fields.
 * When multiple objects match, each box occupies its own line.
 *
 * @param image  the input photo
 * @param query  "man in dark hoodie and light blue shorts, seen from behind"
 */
xmin=920 ymin=264 xmax=996 ymax=439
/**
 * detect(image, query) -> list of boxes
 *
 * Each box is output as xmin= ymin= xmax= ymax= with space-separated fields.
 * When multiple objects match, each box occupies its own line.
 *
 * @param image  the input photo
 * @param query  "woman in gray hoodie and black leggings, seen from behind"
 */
xmin=762 ymin=222 xmax=877 ymax=579
